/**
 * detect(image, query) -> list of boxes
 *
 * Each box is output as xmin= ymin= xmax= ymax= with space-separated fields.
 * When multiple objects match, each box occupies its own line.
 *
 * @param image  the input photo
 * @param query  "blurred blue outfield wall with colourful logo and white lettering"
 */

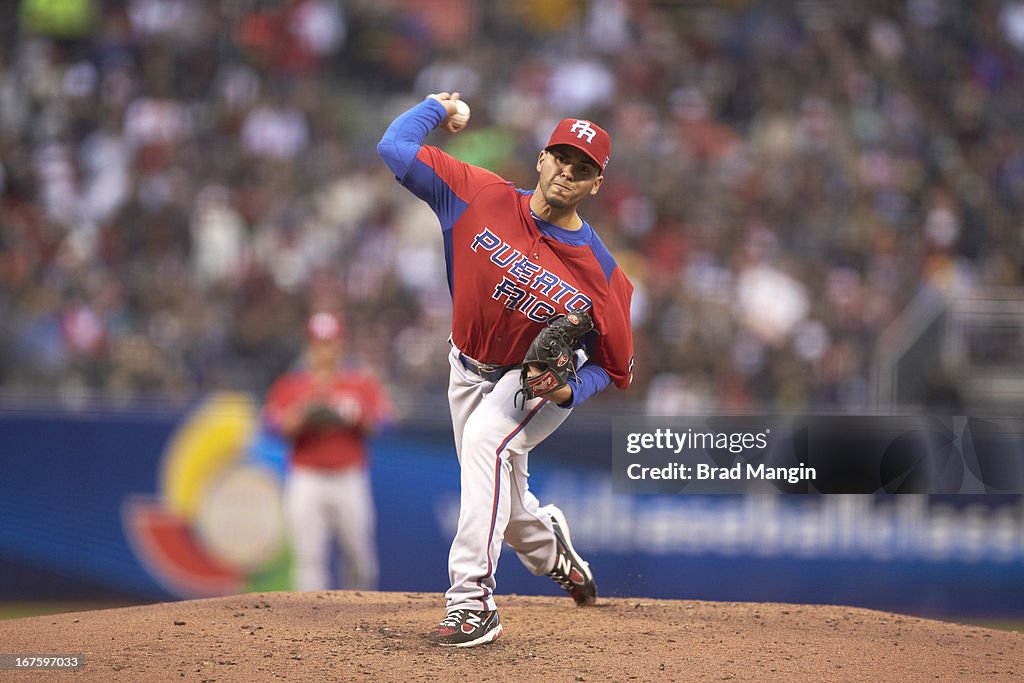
xmin=0 ymin=396 xmax=1024 ymax=617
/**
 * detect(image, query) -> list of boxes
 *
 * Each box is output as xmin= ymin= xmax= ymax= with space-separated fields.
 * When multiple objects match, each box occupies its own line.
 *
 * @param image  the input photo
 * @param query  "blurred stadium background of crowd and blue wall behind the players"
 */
xmin=0 ymin=0 xmax=1024 ymax=618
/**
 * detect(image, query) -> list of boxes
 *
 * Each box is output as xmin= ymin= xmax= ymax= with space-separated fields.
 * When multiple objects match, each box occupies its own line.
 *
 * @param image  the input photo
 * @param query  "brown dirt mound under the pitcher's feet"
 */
xmin=0 ymin=592 xmax=1024 ymax=682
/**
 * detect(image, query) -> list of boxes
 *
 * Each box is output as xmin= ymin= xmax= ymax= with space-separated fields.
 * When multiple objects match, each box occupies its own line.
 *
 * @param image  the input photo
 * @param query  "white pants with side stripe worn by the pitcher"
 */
xmin=445 ymin=346 xmax=571 ymax=612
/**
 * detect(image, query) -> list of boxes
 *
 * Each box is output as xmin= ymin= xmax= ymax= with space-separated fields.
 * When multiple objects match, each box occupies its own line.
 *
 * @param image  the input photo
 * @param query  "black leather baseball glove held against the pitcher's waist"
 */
xmin=516 ymin=311 xmax=594 ymax=408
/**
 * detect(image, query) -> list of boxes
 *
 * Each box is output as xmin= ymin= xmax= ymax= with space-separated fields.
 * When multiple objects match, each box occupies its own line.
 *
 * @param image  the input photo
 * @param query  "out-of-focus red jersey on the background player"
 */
xmin=264 ymin=371 xmax=391 ymax=470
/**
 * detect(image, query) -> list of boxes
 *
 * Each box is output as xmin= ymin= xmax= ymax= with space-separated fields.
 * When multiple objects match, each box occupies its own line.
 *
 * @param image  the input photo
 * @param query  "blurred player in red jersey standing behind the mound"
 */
xmin=265 ymin=312 xmax=391 ymax=591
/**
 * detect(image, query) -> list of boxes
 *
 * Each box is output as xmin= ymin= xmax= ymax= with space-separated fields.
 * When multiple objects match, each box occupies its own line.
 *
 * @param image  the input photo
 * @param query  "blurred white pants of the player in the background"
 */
xmin=285 ymin=467 xmax=378 ymax=591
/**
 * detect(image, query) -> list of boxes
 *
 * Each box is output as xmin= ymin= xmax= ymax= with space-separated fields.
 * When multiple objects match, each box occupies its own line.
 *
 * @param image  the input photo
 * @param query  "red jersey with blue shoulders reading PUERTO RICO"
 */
xmin=401 ymin=145 xmax=633 ymax=389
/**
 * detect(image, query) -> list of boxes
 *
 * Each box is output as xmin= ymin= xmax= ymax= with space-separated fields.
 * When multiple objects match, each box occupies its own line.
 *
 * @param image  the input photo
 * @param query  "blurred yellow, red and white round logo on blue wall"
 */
xmin=122 ymin=393 xmax=288 ymax=598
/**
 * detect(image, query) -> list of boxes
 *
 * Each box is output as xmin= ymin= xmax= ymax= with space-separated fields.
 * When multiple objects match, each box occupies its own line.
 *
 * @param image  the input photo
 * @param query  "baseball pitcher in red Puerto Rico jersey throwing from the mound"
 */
xmin=377 ymin=92 xmax=633 ymax=647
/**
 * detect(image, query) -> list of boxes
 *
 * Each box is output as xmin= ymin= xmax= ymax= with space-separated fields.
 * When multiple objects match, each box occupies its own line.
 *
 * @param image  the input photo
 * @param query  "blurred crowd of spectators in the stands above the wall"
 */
xmin=0 ymin=0 xmax=1024 ymax=415
